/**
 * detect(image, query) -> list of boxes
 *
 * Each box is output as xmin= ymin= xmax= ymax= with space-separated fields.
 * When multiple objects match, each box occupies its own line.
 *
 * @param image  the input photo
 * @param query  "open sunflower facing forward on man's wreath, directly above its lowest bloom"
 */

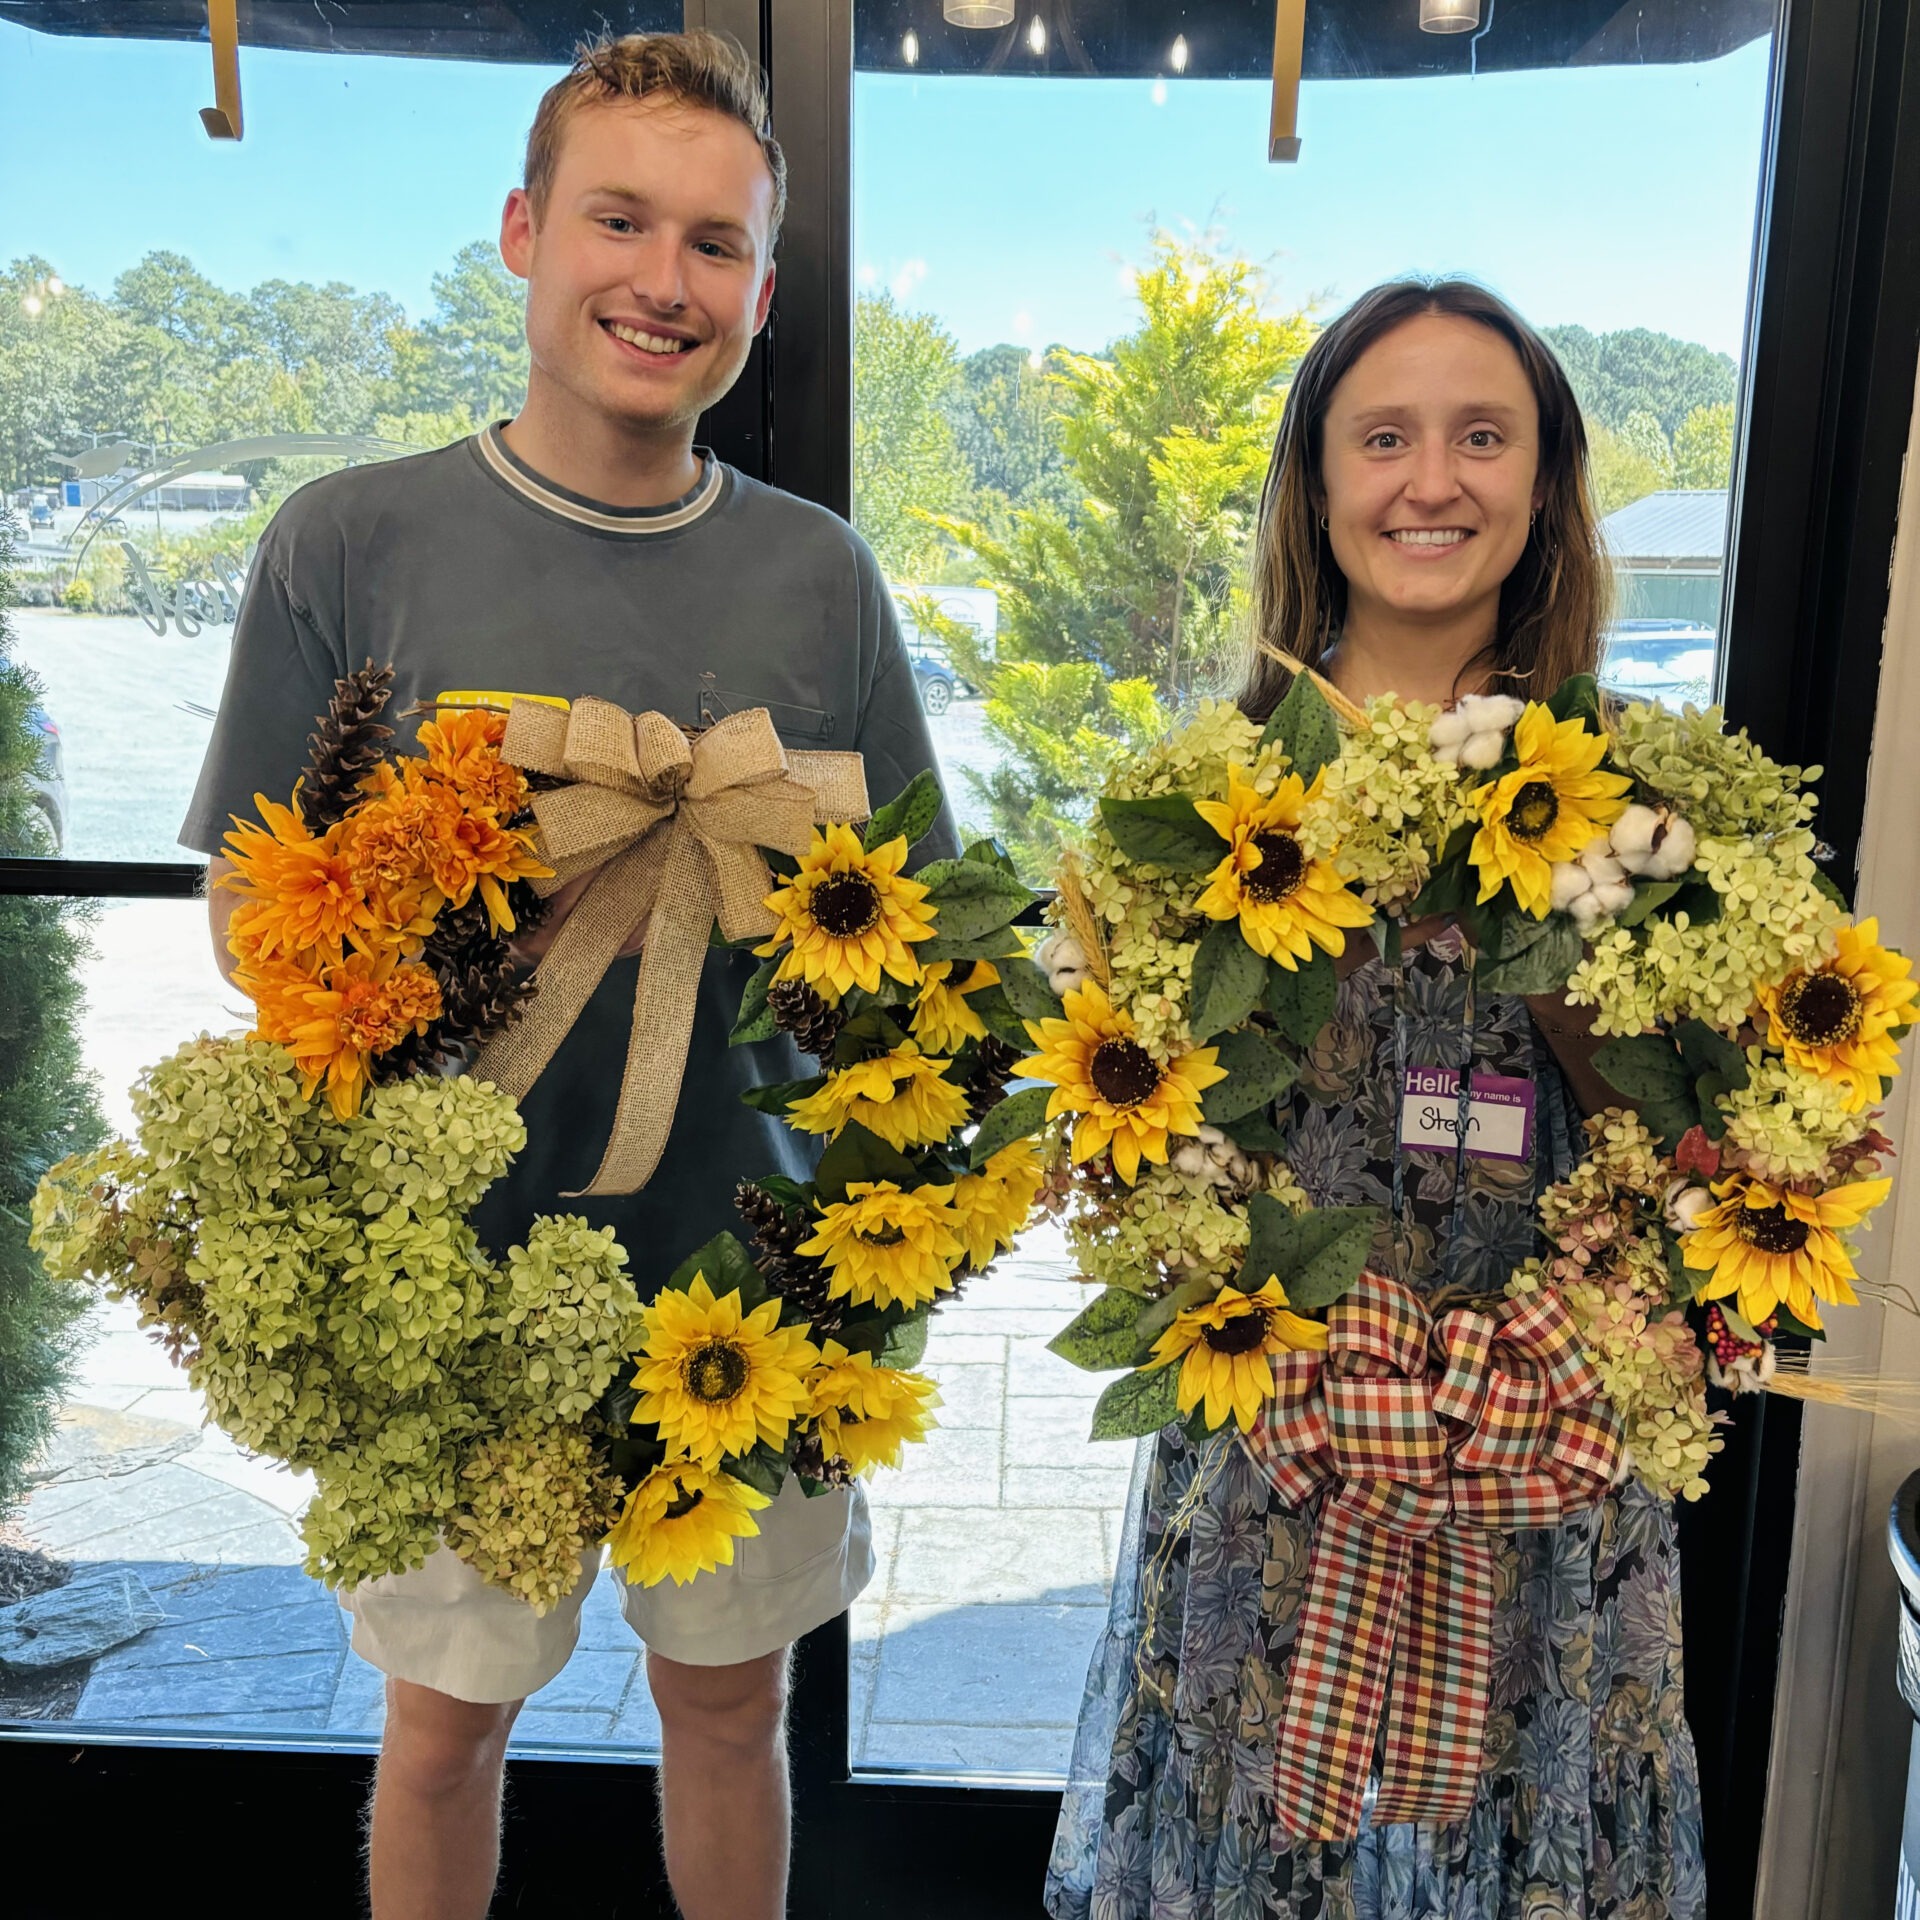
xmin=630 ymin=1273 xmax=818 ymax=1467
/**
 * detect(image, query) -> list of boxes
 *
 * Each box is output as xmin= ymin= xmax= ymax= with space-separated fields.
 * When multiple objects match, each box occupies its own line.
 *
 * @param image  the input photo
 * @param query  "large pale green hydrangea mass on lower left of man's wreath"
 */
xmin=33 ymin=1037 xmax=643 ymax=1607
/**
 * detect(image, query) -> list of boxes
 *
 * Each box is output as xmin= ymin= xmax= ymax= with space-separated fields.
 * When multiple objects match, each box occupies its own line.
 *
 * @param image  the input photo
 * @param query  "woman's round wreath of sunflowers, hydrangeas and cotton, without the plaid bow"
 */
xmin=1021 ymin=674 xmax=1920 ymax=1498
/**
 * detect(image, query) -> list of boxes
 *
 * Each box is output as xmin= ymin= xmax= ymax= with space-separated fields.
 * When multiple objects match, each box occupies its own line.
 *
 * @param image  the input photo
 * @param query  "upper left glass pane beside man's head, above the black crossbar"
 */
xmin=0 ymin=0 xmax=660 ymax=860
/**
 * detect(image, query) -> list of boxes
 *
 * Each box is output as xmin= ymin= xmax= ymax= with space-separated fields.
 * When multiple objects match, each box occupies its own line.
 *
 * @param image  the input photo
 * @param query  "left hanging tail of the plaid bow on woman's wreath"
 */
xmin=1273 ymin=1488 xmax=1413 ymax=1845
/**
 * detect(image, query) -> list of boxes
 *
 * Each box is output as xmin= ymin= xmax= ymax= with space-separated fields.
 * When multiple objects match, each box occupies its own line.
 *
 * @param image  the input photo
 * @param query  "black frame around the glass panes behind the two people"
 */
xmin=0 ymin=0 xmax=1920 ymax=1920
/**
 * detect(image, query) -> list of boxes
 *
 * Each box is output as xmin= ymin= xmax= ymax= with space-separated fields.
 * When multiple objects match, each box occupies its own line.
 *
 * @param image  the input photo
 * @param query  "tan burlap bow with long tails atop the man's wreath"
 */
xmin=474 ymin=699 xmax=868 ymax=1198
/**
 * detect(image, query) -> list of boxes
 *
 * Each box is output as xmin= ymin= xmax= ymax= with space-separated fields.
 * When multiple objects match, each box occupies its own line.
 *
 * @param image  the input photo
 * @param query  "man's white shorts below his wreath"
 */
xmin=340 ymin=1478 xmax=874 ymax=1701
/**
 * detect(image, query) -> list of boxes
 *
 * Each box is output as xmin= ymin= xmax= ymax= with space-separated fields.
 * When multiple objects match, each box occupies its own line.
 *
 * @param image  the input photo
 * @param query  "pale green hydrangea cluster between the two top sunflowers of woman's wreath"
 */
xmin=1300 ymin=693 xmax=1473 ymax=914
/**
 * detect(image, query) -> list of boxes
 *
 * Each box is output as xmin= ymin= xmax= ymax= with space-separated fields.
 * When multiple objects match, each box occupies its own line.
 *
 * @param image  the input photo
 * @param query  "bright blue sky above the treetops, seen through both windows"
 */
xmin=0 ymin=25 xmax=1768 ymax=351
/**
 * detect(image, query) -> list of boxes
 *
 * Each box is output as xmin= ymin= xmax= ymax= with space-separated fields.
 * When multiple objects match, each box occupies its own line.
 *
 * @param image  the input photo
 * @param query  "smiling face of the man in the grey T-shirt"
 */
xmin=501 ymin=98 xmax=774 ymax=430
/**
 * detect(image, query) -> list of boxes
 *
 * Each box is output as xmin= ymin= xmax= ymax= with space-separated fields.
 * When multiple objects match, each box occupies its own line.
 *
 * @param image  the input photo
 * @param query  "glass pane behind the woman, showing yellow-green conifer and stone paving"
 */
xmin=854 ymin=0 xmax=1770 ymax=1774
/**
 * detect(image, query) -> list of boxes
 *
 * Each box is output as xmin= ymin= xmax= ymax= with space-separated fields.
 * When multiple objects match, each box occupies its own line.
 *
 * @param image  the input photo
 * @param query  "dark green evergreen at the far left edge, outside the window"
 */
xmin=0 ymin=515 xmax=104 ymax=1519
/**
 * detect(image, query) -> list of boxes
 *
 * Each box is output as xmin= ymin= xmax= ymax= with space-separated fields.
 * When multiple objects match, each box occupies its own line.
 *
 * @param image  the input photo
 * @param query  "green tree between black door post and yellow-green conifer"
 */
xmin=852 ymin=294 xmax=968 ymax=580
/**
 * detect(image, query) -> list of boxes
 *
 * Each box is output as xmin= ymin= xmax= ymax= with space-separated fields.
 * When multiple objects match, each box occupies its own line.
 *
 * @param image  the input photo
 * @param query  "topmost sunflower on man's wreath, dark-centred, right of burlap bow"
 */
xmin=755 ymin=826 xmax=933 ymax=1002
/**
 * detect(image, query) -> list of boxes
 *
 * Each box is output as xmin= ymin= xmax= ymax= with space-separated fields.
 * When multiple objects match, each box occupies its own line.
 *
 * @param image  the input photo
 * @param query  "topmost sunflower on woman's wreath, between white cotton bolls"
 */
xmin=1467 ymin=701 xmax=1632 ymax=920
